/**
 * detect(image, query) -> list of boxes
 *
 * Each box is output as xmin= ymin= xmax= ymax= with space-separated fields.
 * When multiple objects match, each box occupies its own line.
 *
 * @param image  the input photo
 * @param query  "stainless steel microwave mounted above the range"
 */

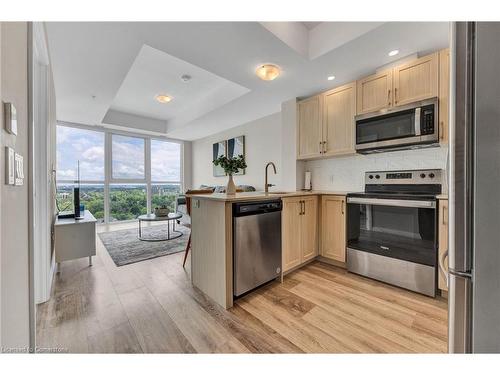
xmin=355 ymin=98 xmax=439 ymax=154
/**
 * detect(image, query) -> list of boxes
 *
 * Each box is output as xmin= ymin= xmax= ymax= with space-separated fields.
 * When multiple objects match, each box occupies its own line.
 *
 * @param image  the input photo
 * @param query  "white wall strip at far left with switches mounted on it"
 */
xmin=0 ymin=22 xmax=30 ymax=347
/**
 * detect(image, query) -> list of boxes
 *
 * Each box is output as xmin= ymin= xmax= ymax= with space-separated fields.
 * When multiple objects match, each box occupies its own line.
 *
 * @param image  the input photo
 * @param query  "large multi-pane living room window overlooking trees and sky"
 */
xmin=57 ymin=125 xmax=182 ymax=222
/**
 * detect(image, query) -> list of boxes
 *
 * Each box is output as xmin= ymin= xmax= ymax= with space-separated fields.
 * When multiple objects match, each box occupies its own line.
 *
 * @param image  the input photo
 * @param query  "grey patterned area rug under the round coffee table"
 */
xmin=99 ymin=225 xmax=189 ymax=267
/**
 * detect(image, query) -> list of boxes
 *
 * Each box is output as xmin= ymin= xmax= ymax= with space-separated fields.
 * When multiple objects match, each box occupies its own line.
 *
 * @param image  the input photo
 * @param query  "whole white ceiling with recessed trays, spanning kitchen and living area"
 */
xmin=46 ymin=22 xmax=449 ymax=140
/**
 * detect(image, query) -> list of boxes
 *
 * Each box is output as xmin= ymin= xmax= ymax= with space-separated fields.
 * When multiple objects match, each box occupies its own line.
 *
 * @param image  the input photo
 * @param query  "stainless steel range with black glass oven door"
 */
xmin=347 ymin=170 xmax=441 ymax=296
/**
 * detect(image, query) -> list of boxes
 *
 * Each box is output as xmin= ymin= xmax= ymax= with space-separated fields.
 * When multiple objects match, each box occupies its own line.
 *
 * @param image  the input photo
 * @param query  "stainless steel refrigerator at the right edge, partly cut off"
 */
xmin=448 ymin=22 xmax=500 ymax=353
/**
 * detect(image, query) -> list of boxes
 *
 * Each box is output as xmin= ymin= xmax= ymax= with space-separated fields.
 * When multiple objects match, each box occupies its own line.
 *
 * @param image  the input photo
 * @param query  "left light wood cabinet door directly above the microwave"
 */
xmin=356 ymin=69 xmax=393 ymax=115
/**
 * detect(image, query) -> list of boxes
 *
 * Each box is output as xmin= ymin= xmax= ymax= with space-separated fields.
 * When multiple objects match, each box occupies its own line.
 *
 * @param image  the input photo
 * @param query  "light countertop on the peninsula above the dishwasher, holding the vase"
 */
xmin=189 ymin=190 xmax=349 ymax=202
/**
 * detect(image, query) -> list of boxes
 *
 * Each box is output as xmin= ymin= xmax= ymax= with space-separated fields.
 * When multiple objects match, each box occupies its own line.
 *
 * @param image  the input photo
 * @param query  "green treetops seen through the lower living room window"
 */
xmin=57 ymin=184 xmax=180 ymax=222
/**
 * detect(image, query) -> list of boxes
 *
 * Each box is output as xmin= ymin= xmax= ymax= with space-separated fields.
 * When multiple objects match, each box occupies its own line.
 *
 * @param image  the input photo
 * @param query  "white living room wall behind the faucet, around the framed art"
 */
xmin=192 ymin=112 xmax=282 ymax=190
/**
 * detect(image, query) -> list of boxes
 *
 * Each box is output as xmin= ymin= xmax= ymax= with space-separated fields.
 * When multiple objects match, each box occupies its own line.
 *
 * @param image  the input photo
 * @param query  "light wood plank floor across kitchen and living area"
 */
xmin=37 ymin=224 xmax=447 ymax=353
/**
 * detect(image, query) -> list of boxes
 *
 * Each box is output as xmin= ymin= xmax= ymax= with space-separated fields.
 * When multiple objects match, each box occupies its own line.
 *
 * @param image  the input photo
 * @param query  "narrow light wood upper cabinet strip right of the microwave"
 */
xmin=439 ymin=48 xmax=450 ymax=143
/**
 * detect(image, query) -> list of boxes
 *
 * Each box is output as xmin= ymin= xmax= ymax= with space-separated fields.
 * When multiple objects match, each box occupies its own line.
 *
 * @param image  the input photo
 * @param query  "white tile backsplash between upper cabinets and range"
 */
xmin=305 ymin=147 xmax=448 ymax=191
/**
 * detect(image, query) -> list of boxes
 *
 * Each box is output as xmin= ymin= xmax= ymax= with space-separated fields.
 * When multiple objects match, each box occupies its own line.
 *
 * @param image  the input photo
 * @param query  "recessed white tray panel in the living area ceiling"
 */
xmin=110 ymin=45 xmax=249 ymax=125
